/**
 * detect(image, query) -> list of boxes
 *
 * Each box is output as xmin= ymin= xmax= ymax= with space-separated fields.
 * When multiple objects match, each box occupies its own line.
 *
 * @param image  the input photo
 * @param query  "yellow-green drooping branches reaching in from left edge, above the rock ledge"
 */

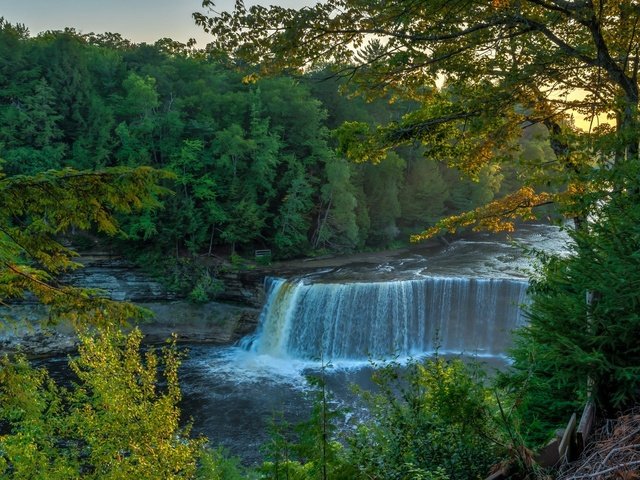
xmin=0 ymin=167 xmax=166 ymax=325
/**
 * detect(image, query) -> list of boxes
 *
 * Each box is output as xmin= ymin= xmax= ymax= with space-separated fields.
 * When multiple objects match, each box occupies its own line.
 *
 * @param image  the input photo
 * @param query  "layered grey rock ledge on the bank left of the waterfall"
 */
xmin=0 ymin=252 xmax=264 ymax=356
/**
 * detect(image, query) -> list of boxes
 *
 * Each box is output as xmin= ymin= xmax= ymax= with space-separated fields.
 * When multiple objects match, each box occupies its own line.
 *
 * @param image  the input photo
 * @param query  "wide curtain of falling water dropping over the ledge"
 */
xmin=245 ymin=277 xmax=527 ymax=361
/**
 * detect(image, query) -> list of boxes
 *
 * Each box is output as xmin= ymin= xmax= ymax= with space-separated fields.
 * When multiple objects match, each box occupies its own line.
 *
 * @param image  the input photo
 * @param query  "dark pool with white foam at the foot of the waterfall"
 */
xmin=181 ymin=345 xmax=506 ymax=465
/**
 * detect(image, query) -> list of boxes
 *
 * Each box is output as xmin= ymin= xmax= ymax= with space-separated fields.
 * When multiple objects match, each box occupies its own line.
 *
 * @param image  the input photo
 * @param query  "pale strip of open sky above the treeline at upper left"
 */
xmin=0 ymin=0 xmax=311 ymax=47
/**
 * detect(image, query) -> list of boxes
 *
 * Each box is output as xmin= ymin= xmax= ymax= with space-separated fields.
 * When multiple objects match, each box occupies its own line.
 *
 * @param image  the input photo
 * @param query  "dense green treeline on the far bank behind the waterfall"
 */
xmin=0 ymin=20 xmax=553 ymax=258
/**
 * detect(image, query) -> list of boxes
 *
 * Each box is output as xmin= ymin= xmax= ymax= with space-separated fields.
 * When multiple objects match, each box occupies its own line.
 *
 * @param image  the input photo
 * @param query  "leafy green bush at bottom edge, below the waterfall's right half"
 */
xmin=349 ymin=357 xmax=502 ymax=480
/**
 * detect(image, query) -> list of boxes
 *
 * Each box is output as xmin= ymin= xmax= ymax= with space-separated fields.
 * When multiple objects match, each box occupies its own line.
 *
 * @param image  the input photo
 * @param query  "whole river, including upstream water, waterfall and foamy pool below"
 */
xmin=38 ymin=225 xmax=567 ymax=464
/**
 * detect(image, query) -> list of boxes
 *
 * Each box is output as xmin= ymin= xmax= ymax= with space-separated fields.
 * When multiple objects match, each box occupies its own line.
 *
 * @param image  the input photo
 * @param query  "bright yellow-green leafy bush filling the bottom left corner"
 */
xmin=0 ymin=328 xmax=204 ymax=480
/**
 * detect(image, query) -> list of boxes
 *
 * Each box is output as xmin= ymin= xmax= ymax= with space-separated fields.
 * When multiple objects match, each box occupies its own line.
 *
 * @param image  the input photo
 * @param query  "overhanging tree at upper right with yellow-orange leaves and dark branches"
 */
xmin=194 ymin=0 xmax=640 ymax=235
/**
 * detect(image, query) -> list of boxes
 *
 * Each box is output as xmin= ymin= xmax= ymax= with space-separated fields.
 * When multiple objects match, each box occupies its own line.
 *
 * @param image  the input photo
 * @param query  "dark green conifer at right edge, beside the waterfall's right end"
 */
xmin=505 ymin=165 xmax=640 ymax=442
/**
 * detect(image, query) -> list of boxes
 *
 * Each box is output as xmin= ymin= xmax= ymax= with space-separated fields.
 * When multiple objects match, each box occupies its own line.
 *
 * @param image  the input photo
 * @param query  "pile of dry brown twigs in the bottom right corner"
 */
xmin=558 ymin=408 xmax=640 ymax=480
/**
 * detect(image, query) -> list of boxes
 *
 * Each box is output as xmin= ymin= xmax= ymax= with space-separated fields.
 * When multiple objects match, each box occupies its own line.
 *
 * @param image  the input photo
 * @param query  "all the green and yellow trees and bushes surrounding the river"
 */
xmin=0 ymin=0 xmax=640 ymax=480
